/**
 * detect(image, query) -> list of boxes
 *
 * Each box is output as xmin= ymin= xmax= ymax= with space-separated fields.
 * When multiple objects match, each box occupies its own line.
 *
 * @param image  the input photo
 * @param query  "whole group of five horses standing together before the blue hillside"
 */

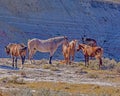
xmin=5 ymin=36 xmax=103 ymax=68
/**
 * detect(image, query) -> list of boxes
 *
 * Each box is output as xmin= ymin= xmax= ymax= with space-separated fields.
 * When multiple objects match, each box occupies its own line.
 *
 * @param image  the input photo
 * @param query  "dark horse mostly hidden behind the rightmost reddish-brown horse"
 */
xmin=82 ymin=37 xmax=97 ymax=47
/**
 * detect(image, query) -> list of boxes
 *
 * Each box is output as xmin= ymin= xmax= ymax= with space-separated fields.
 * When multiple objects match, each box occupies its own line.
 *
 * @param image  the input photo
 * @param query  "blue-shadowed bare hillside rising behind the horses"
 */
xmin=0 ymin=0 xmax=120 ymax=60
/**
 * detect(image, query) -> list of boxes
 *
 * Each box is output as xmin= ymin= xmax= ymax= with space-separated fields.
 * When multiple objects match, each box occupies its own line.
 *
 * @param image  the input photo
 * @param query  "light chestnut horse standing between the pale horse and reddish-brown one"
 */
xmin=62 ymin=40 xmax=78 ymax=64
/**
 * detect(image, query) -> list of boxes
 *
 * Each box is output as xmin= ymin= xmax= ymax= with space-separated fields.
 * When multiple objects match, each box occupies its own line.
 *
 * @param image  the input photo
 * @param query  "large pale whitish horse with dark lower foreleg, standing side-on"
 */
xmin=28 ymin=36 xmax=68 ymax=64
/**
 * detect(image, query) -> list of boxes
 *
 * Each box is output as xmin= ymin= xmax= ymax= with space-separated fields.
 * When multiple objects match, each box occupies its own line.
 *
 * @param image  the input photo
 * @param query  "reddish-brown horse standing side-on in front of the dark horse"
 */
xmin=77 ymin=44 xmax=103 ymax=69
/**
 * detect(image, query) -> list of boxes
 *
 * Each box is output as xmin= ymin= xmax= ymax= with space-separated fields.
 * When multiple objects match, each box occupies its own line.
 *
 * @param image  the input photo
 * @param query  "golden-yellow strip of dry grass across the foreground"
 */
xmin=24 ymin=82 xmax=120 ymax=96
